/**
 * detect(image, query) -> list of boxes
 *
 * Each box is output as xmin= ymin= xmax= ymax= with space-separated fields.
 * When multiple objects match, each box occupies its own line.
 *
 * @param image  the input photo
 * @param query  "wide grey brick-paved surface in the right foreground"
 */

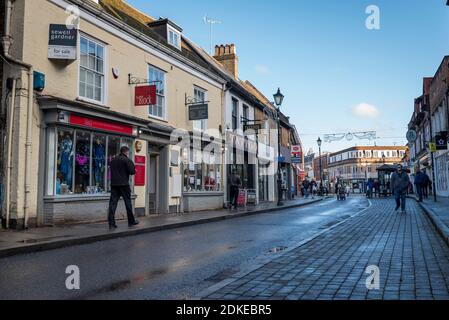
xmin=204 ymin=199 xmax=449 ymax=300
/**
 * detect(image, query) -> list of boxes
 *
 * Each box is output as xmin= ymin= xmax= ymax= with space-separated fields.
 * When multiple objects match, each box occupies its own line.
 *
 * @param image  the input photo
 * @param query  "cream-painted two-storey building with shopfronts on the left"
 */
xmin=2 ymin=0 xmax=226 ymax=228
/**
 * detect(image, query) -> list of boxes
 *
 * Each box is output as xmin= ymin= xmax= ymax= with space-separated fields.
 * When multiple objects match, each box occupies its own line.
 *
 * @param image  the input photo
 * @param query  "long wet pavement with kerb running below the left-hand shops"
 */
xmin=0 ymin=198 xmax=322 ymax=257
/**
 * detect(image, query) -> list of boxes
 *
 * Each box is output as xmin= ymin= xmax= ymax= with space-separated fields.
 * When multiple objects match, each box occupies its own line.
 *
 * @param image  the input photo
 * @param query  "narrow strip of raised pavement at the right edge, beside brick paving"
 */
xmin=414 ymin=197 xmax=449 ymax=245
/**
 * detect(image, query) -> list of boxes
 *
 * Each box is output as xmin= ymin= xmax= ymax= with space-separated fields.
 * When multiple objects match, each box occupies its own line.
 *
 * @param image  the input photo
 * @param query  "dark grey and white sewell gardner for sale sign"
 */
xmin=48 ymin=24 xmax=78 ymax=60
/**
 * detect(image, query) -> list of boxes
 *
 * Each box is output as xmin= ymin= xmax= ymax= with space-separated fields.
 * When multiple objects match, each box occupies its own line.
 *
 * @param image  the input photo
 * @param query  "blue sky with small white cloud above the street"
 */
xmin=128 ymin=0 xmax=449 ymax=151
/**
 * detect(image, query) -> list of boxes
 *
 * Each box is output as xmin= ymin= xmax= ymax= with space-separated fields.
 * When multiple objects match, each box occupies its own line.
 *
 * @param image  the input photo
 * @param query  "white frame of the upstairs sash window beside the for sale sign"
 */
xmin=76 ymin=32 xmax=109 ymax=107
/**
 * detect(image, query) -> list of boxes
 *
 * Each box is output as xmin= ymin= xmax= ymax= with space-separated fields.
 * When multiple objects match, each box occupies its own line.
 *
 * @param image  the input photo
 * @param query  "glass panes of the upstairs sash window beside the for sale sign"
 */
xmin=79 ymin=36 xmax=105 ymax=103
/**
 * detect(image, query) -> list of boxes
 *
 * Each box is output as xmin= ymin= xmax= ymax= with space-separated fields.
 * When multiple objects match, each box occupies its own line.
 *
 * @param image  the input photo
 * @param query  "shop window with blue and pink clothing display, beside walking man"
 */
xmin=46 ymin=127 xmax=134 ymax=196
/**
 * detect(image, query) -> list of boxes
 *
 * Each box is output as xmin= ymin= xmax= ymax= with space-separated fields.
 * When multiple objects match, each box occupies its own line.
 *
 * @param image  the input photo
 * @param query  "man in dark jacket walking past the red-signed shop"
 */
xmin=108 ymin=146 xmax=139 ymax=229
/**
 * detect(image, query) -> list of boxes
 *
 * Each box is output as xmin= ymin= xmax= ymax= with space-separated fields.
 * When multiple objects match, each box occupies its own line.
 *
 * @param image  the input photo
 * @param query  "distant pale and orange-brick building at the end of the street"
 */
xmin=328 ymin=146 xmax=406 ymax=193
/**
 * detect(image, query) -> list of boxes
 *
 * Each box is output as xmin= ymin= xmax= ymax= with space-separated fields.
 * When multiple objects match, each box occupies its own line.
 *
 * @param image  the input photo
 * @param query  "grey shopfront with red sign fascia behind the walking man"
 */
xmin=38 ymin=99 xmax=150 ymax=225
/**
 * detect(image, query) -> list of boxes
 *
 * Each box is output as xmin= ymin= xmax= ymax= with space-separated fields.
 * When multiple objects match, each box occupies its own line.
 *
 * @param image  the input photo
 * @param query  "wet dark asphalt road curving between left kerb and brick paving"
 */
xmin=0 ymin=197 xmax=368 ymax=299
